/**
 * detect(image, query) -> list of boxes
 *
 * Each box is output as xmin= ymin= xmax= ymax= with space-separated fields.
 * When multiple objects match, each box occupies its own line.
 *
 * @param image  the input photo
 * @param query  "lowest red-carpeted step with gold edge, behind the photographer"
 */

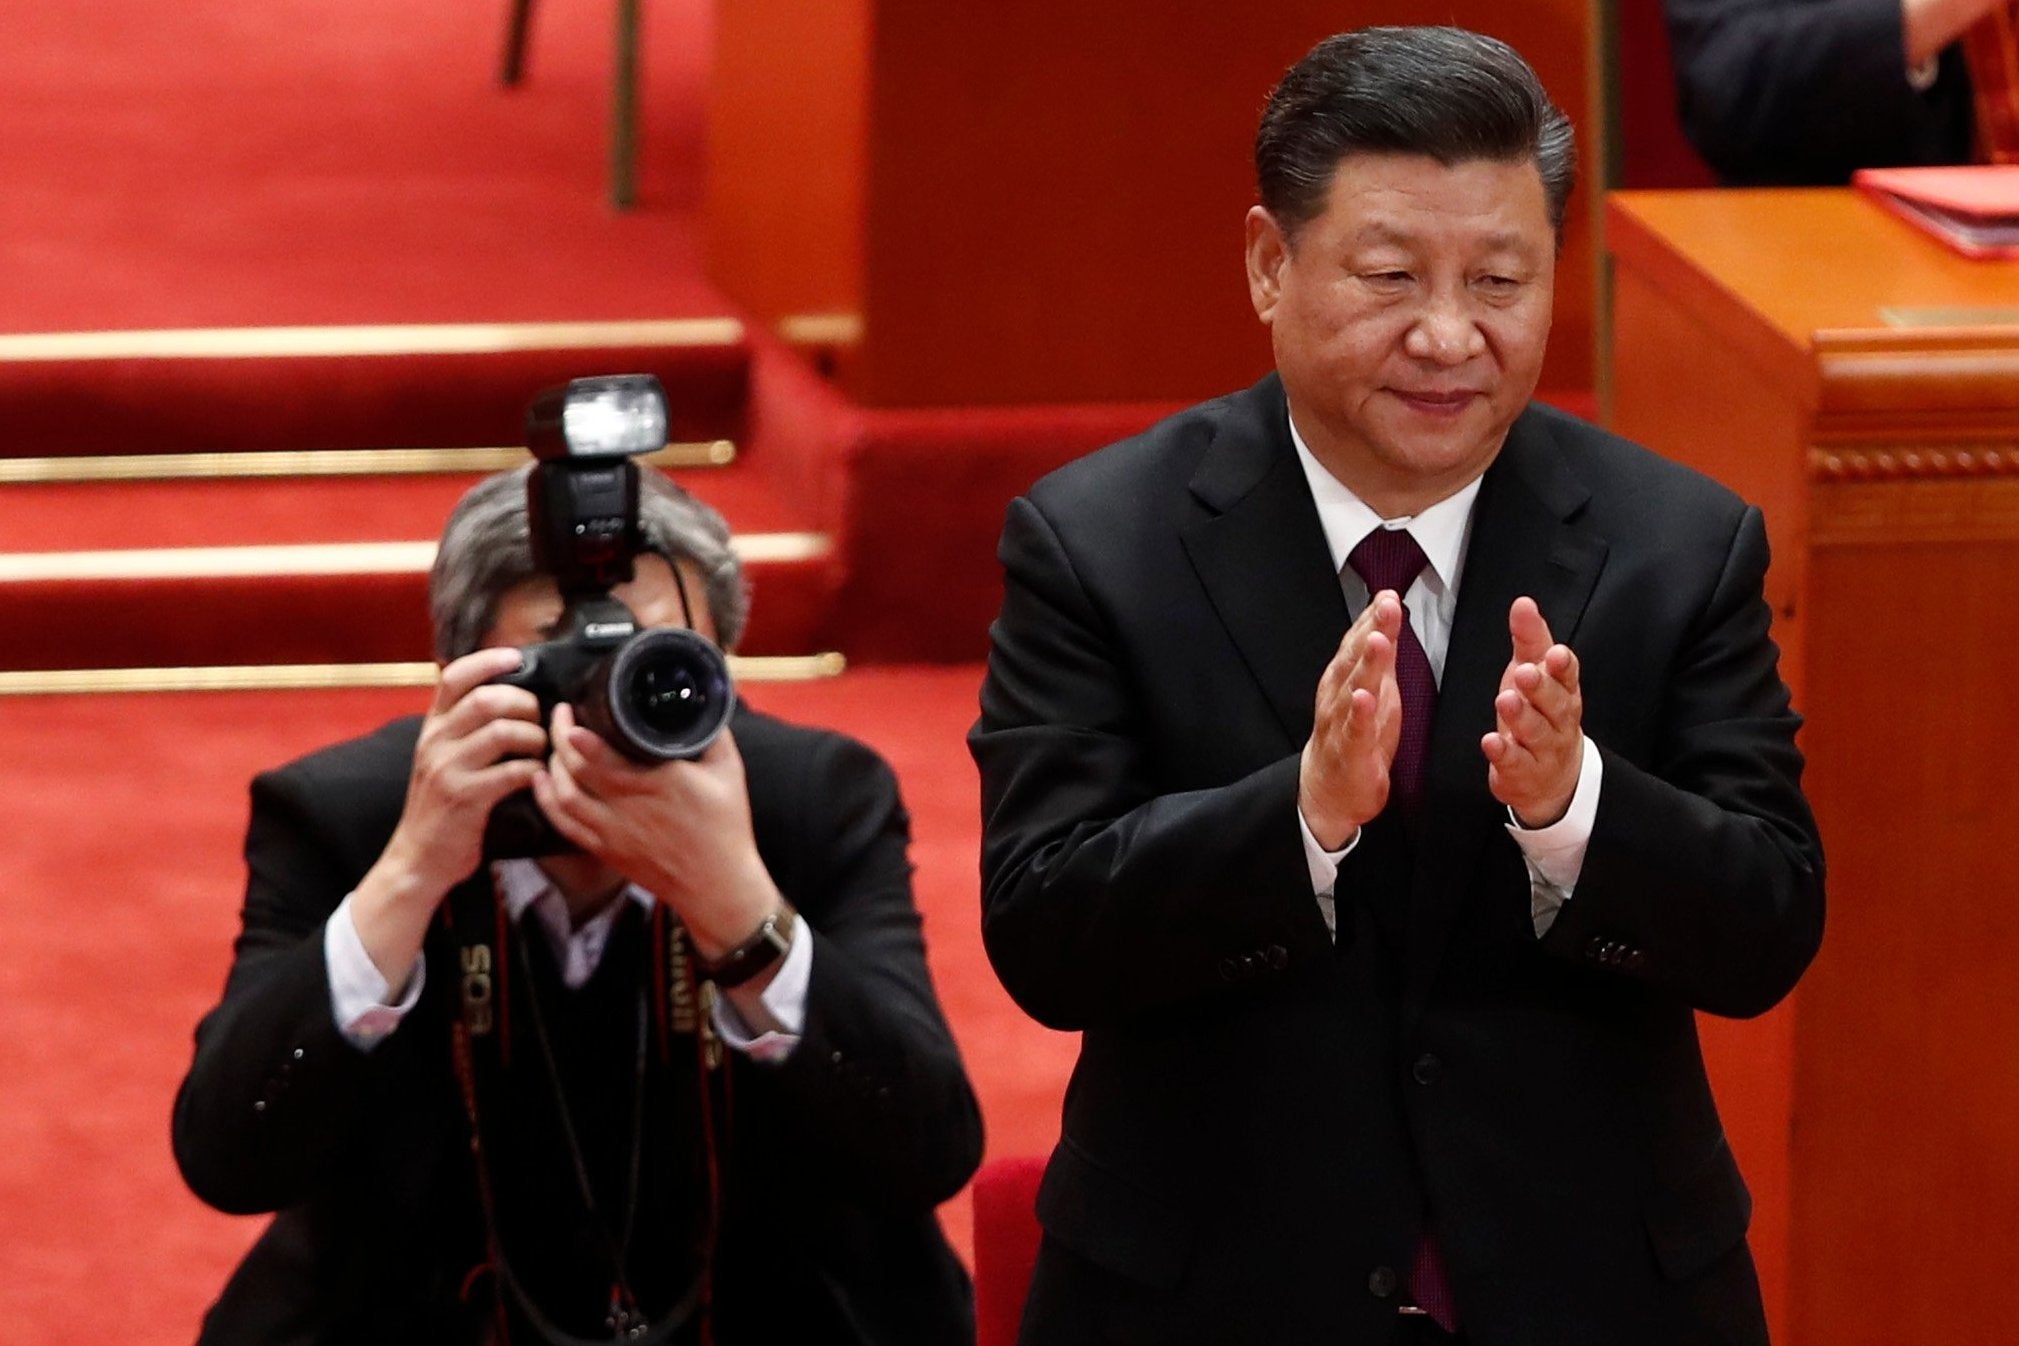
xmin=0 ymin=462 xmax=834 ymax=670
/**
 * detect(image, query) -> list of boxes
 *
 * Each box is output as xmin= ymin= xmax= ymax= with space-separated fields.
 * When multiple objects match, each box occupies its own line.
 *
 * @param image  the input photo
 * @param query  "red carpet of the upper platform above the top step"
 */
xmin=0 ymin=0 xmax=719 ymax=331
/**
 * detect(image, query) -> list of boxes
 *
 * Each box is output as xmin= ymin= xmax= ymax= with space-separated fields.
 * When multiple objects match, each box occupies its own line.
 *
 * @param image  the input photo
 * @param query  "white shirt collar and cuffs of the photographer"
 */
xmin=323 ymin=860 xmax=814 ymax=1061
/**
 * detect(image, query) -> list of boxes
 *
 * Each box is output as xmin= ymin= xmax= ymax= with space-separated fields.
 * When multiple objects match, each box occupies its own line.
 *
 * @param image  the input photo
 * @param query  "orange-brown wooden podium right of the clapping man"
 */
xmin=1607 ymin=190 xmax=2019 ymax=1346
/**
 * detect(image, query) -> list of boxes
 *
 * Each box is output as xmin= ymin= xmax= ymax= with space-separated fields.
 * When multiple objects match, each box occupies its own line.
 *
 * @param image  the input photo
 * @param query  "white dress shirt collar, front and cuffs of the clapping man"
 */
xmin=1290 ymin=420 xmax=1603 ymax=938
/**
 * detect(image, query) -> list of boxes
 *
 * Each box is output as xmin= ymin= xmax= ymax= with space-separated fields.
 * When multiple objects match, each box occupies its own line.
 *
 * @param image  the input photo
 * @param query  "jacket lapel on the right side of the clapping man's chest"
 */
xmin=1403 ymin=410 xmax=1607 ymax=1025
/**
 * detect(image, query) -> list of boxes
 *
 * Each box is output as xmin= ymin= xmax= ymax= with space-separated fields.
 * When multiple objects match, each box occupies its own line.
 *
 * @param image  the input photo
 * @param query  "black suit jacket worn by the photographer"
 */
xmin=176 ymin=710 xmax=981 ymax=1346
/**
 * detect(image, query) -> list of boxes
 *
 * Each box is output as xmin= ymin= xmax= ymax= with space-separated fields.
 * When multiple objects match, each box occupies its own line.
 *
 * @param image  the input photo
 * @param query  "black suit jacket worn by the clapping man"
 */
xmin=971 ymin=377 xmax=1823 ymax=1346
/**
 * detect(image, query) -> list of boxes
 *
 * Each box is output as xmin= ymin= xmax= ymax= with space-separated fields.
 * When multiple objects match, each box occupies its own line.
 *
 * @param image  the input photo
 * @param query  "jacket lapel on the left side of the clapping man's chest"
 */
xmin=1183 ymin=375 xmax=1347 ymax=745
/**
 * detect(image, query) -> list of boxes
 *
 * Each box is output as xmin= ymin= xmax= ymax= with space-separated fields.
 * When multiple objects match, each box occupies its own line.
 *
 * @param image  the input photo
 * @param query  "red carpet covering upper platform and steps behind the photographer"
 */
xmin=0 ymin=0 xmax=868 ymax=668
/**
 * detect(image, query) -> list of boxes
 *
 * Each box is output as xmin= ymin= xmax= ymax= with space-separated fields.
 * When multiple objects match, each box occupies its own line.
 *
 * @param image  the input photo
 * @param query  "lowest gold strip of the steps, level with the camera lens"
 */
xmin=0 ymin=652 xmax=848 ymax=696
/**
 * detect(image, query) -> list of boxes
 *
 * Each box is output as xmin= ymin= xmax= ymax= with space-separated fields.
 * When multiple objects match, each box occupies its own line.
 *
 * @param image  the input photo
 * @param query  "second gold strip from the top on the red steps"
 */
xmin=0 ymin=440 xmax=737 ymax=486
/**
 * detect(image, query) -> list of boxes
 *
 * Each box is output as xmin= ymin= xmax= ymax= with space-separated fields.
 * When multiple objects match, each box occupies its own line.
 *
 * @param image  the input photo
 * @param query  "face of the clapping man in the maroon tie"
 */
xmin=1248 ymin=153 xmax=1557 ymax=517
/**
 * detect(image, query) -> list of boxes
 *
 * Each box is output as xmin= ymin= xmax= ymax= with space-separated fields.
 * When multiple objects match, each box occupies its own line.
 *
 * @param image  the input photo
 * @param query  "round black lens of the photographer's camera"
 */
xmin=604 ymin=628 xmax=735 ymax=761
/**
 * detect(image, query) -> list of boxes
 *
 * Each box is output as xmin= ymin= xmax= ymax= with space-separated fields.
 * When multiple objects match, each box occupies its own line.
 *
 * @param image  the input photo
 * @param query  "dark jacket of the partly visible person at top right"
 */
xmin=1662 ymin=0 xmax=1973 ymax=188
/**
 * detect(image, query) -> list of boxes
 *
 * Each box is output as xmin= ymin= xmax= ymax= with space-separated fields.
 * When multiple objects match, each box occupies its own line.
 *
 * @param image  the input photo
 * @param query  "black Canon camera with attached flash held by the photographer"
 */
xmin=485 ymin=373 xmax=735 ymax=860
